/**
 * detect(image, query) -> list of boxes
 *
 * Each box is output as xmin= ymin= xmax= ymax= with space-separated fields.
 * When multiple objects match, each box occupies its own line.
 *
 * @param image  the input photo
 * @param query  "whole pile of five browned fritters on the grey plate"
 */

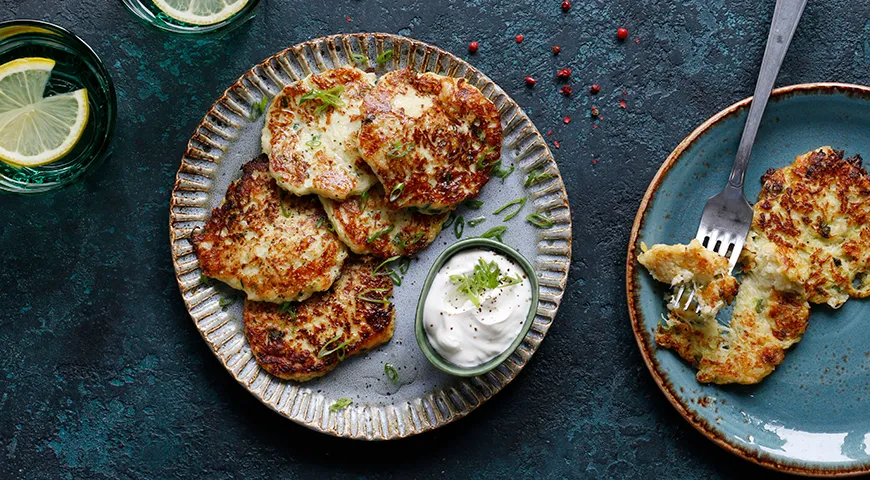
xmin=193 ymin=67 xmax=502 ymax=381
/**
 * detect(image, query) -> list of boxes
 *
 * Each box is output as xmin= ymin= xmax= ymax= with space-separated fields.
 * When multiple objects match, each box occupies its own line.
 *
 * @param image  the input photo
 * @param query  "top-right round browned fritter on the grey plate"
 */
xmin=359 ymin=69 xmax=502 ymax=213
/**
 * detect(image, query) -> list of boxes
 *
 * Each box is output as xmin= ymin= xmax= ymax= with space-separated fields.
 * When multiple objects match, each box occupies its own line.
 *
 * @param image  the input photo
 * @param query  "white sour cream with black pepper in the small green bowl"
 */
xmin=423 ymin=249 xmax=532 ymax=367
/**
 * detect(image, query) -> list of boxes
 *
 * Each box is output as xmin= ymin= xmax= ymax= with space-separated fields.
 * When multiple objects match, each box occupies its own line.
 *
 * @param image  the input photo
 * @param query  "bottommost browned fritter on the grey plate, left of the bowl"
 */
xmin=243 ymin=258 xmax=395 ymax=382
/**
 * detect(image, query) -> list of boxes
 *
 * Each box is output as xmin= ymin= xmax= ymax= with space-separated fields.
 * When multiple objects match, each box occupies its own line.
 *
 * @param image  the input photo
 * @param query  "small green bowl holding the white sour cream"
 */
xmin=415 ymin=237 xmax=539 ymax=377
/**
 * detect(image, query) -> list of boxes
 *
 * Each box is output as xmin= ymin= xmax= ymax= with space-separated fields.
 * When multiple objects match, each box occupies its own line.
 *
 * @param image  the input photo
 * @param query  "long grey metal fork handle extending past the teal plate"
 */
xmin=728 ymin=0 xmax=807 ymax=189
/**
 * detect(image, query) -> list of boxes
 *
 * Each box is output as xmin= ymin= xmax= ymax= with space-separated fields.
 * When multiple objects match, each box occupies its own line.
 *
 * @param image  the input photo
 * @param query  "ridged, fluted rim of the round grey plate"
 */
xmin=169 ymin=32 xmax=573 ymax=440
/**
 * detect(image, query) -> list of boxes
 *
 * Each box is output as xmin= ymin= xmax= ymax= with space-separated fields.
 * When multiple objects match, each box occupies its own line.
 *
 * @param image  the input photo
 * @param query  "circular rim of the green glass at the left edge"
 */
xmin=0 ymin=19 xmax=118 ymax=194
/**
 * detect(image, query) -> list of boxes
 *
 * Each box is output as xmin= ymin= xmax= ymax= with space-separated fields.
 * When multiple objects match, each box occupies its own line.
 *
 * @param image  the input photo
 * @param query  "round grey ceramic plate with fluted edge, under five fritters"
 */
xmin=169 ymin=34 xmax=571 ymax=440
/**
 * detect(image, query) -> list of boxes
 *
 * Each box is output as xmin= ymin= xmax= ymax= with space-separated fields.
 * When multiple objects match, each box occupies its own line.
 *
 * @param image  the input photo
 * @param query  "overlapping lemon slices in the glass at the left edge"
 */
xmin=0 ymin=57 xmax=88 ymax=167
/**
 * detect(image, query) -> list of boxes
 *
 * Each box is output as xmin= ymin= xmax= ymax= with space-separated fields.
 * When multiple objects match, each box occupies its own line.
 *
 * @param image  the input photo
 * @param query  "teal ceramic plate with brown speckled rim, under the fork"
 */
xmin=626 ymin=84 xmax=870 ymax=476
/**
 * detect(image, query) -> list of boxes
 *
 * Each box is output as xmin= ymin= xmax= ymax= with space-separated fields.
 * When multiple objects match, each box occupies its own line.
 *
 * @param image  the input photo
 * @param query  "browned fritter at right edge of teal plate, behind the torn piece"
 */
xmin=744 ymin=147 xmax=870 ymax=308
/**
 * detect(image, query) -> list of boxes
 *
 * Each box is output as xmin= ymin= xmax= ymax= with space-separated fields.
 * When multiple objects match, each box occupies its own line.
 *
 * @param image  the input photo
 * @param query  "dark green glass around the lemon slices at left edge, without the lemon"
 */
xmin=0 ymin=20 xmax=118 ymax=193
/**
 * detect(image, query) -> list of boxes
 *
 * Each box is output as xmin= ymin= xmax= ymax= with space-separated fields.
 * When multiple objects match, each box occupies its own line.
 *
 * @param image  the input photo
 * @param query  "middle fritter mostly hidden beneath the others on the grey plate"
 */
xmin=320 ymin=185 xmax=447 ymax=258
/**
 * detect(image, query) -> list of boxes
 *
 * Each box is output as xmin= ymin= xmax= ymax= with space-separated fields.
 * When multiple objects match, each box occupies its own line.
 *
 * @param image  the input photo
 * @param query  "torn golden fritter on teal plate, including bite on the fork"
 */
xmin=638 ymin=147 xmax=870 ymax=384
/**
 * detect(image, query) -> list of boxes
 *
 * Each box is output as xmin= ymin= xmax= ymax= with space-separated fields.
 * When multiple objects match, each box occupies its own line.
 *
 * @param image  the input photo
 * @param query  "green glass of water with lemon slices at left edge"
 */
xmin=0 ymin=20 xmax=117 ymax=193
